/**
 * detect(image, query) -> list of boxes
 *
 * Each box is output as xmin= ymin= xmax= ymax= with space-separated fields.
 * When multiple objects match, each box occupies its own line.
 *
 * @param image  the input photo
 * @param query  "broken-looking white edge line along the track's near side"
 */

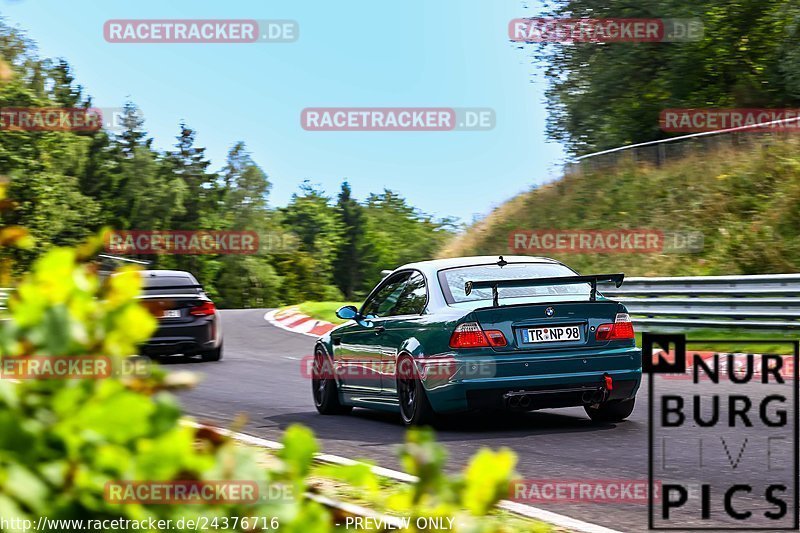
xmin=184 ymin=420 xmax=621 ymax=533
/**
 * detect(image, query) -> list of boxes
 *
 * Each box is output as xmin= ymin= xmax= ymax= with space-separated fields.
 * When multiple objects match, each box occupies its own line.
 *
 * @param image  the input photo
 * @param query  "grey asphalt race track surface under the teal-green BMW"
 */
xmin=173 ymin=309 xmax=794 ymax=531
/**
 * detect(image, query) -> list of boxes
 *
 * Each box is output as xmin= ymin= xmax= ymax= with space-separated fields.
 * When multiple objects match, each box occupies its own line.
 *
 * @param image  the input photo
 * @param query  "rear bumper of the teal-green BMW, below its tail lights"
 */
xmin=422 ymin=347 xmax=642 ymax=412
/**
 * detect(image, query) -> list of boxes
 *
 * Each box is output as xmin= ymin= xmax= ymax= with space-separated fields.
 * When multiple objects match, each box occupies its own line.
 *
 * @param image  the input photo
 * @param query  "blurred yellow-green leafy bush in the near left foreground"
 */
xmin=0 ymin=243 xmax=539 ymax=532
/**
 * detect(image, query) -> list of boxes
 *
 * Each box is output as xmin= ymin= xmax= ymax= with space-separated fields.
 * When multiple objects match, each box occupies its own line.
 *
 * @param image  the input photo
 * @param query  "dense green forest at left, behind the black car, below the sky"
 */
xmin=0 ymin=22 xmax=453 ymax=307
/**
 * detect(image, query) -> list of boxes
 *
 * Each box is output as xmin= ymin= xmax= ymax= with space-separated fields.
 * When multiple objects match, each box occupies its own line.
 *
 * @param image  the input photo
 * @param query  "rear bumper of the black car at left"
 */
xmin=140 ymin=316 xmax=222 ymax=356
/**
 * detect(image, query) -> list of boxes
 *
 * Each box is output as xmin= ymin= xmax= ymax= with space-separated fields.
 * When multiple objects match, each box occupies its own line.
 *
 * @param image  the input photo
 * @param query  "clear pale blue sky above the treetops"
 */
xmin=0 ymin=0 xmax=564 ymax=222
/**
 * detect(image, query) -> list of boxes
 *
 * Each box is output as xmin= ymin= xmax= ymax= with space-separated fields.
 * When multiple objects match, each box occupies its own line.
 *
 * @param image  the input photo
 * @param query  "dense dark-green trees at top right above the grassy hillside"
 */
xmin=536 ymin=0 xmax=800 ymax=155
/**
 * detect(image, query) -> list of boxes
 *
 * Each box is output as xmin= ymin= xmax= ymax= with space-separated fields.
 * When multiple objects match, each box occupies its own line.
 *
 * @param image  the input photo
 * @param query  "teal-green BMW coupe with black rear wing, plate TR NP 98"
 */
xmin=312 ymin=256 xmax=642 ymax=425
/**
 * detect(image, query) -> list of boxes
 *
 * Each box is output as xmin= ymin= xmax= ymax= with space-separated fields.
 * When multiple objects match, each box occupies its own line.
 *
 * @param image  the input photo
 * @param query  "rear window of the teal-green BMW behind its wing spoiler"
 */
xmin=439 ymin=263 xmax=591 ymax=304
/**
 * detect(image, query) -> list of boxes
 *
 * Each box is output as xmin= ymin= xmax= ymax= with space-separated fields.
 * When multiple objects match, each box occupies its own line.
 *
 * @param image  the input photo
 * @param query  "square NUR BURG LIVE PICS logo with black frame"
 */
xmin=642 ymin=333 xmax=800 ymax=531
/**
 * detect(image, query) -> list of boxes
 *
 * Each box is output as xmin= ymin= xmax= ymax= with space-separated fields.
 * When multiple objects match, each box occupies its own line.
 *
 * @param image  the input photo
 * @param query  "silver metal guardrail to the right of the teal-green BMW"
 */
xmin=599 ymin=274 xmax=800 ymax=331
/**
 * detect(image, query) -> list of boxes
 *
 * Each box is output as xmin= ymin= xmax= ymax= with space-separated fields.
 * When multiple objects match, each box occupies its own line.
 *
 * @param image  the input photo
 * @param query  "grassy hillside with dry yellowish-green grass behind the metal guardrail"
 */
xmin=438 ymin=137 xmax=800 ymax=276
